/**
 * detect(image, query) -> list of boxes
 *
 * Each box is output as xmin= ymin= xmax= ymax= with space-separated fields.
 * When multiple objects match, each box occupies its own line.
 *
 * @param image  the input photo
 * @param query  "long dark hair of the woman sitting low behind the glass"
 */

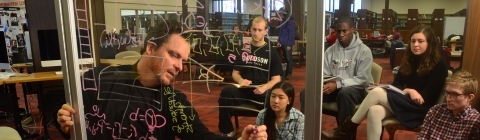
xmin=263 ymin=82 xmax=295 ymax=140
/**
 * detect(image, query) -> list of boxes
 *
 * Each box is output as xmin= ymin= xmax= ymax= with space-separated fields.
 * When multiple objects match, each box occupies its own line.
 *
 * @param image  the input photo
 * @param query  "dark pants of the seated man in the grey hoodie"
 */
xmin=300 ymin=87 xmax=367 ymax=125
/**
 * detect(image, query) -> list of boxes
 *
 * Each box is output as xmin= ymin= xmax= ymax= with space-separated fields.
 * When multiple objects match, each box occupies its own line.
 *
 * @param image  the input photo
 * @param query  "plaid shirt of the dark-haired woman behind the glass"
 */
xmin=255 ymin=108 xmax=305 ymax=140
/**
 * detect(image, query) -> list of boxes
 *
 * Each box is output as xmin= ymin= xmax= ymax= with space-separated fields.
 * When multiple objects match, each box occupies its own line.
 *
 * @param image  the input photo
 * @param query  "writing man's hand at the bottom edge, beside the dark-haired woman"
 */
xmin=238 ymin=125 xmax=268 ymax=140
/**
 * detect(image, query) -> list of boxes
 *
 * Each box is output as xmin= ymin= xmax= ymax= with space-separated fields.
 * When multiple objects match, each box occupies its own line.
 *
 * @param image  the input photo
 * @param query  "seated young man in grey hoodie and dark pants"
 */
xmin=300 ymin=17 xmax=373 ymax=136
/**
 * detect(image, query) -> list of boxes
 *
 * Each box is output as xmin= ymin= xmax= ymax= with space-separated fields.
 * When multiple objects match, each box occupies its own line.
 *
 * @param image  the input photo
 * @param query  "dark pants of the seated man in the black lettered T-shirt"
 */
xmin=218 ymin=85 xmax=265 ymax=134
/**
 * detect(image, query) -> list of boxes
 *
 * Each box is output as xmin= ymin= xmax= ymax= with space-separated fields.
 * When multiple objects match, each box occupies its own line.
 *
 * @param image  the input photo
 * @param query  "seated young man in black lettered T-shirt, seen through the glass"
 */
xmin=218 ymin=17 xmax=282 ymax=136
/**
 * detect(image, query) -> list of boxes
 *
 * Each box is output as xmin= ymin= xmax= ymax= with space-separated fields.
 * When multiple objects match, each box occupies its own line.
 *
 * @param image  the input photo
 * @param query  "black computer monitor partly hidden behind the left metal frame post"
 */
xmin=38 ymin=29 xmax=93 ymax=67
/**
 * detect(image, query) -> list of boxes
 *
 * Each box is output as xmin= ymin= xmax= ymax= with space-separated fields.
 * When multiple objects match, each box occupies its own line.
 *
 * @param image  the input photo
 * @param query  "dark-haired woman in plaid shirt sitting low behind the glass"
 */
xmin=255 ymin=82 xmax=305 ymax=140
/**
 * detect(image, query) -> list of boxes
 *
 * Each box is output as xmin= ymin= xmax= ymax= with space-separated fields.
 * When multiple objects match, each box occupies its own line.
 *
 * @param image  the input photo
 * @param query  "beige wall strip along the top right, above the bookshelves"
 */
xmin=365 ymin=0 xmax=467 ymax=14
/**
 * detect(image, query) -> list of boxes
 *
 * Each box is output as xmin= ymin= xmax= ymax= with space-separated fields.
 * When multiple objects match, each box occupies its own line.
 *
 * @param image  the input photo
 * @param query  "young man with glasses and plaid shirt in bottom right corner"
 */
xmin=418 ymin=70 xmax=480 ymax=140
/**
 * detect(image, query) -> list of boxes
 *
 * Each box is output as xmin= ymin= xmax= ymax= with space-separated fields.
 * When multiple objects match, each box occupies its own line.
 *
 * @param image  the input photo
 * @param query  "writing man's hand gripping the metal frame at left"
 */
xmin=57 ymin=104 xmax=75 ymax=134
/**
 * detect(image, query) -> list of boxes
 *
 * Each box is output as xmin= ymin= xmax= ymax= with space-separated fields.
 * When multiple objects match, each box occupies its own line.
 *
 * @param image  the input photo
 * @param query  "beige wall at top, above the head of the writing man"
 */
xmin=104 ymin=0 xmax=197 ymax=31
